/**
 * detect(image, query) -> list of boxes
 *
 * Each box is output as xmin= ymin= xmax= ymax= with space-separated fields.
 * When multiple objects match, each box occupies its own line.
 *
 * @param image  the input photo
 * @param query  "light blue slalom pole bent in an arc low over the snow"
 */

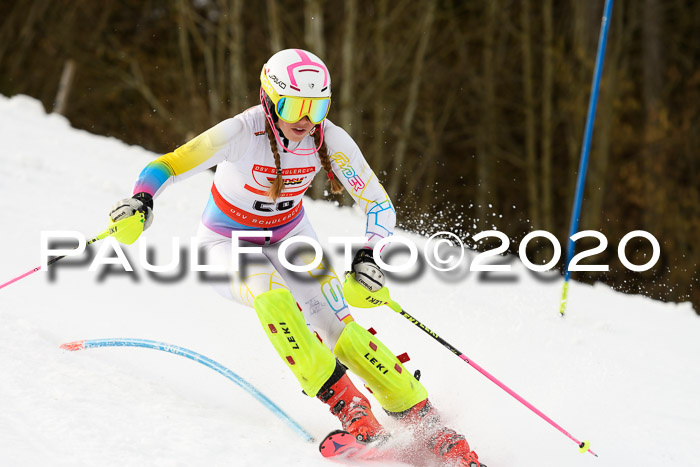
xmin=61 ymin=338 xmax=315 ymax=443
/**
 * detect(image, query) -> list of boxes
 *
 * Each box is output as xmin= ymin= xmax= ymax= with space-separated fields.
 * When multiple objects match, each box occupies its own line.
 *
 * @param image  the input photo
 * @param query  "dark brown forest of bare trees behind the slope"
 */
xmin=0 ymin=0 xmax=700 ymax=311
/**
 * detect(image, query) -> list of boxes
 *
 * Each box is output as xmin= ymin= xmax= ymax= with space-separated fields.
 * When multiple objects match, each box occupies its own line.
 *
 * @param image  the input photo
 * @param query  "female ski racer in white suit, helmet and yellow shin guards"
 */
xmin=110 ymin=49 xmax=480 ymax=467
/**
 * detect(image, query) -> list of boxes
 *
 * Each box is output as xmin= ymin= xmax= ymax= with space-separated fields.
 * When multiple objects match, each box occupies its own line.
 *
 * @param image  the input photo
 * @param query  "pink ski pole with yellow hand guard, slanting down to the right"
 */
xmin=343 ymin=274 xmax=598 ymax=457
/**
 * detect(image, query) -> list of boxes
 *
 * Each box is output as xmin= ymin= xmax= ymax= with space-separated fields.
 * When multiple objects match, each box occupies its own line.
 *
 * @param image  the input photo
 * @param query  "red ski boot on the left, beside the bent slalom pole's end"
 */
xmin=317 ymin=361 xmax=386 ymax=443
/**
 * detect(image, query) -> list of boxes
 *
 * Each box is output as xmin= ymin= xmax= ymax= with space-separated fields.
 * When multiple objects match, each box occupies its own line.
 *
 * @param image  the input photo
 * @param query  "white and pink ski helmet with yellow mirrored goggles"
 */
xmin=260 ymin=49 xmax=331 ymax=124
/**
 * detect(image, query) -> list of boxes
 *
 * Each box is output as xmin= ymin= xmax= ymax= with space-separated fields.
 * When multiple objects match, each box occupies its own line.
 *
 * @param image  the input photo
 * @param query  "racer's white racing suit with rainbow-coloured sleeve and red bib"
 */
xmin=134 ymin=106 xmax=396 ymax=350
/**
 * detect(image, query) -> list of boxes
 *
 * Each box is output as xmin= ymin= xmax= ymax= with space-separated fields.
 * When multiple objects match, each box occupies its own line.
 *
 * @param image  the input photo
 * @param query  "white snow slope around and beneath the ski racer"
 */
xmin=0 ymin=96 xmax=700 ymax=467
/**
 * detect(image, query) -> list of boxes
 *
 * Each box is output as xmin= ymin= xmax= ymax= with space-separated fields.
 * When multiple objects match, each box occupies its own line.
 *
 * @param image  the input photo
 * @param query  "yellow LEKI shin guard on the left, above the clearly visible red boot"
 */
xmin=253 ymin=289 xmax=335 ymax=397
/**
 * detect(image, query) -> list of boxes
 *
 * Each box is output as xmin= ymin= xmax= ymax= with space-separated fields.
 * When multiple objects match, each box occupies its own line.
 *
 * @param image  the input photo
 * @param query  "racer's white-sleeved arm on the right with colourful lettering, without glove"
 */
xmin=325 ymin=122 xmax=396 ymax=249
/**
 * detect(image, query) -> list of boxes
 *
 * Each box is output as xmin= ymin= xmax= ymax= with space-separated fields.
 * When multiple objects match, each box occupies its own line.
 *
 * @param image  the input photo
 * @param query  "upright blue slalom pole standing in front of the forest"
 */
xmin=559 ymin=0 xmax=613 ymax=316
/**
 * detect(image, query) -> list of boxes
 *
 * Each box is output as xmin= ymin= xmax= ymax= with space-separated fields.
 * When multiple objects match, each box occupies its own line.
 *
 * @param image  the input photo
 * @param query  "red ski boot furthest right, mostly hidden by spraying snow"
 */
xmin=388 ymin=399 xmax=486 ymax=467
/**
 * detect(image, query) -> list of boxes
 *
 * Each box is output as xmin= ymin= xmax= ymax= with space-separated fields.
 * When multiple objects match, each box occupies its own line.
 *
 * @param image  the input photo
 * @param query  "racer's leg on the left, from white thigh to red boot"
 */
xmin=194 ymin=226 xmax=383 ymax=441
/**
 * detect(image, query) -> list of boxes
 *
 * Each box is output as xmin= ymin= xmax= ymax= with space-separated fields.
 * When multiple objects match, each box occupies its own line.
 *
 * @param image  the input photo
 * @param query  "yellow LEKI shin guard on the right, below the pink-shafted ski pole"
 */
xmin=334 ymin=322 xmax=428 ymax=412
